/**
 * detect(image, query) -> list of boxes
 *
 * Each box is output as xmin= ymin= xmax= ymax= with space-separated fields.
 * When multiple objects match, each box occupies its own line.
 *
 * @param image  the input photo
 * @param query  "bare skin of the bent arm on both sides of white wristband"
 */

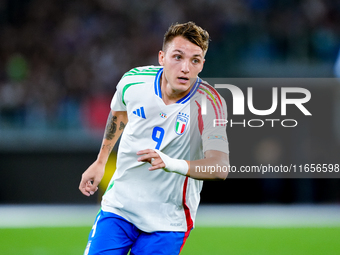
xmin=137 ymin=149 xmax=229 ymax=180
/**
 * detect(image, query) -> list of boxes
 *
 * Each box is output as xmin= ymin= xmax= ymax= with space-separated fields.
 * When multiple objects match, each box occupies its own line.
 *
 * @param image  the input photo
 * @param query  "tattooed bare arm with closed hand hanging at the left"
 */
xmin=79 ymin=111 xmax=128 ymax=196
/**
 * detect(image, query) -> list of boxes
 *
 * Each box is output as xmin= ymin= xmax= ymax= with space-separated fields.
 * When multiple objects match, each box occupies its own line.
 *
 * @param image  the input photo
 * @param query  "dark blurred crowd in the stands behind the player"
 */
xmin=0 ymin=0 xmax=340 ymax=130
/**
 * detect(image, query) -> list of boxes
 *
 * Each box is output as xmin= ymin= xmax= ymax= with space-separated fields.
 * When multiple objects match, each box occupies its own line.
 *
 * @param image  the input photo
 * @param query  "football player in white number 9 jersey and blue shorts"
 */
xmin=79 ymin=22 xmax=229 ymax=255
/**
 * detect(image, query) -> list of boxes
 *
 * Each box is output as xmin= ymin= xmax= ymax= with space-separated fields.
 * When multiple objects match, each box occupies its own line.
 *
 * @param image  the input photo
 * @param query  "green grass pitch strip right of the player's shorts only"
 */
xmin=181 ymin=228 xmax=340 ymax=255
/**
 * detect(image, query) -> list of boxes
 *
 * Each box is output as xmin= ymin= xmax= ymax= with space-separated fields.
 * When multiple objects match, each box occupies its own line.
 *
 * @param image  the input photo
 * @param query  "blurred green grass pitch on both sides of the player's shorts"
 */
xmin=0 ymin=227 xmax=340 ymax=255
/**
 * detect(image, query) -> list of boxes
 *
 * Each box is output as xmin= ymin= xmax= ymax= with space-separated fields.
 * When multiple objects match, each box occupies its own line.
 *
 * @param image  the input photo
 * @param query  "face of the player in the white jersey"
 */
xmin=158 ymin=36 xmax=205 ymax=93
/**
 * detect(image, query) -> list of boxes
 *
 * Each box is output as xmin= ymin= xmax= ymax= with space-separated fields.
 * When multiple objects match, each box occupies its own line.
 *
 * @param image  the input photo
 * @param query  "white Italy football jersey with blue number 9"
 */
xmin=102 ymin=66 xmax=229 ymax=232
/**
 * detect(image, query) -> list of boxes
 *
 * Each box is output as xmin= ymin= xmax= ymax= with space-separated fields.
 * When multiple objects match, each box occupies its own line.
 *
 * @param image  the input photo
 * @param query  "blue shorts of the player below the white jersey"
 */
xmin=84 ymin=210 xmax=190 ymax=255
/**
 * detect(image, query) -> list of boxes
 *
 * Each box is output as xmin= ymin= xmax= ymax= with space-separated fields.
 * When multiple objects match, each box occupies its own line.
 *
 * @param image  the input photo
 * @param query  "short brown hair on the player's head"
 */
xmin=163 ymin=21 xmax=209 ymax=55
